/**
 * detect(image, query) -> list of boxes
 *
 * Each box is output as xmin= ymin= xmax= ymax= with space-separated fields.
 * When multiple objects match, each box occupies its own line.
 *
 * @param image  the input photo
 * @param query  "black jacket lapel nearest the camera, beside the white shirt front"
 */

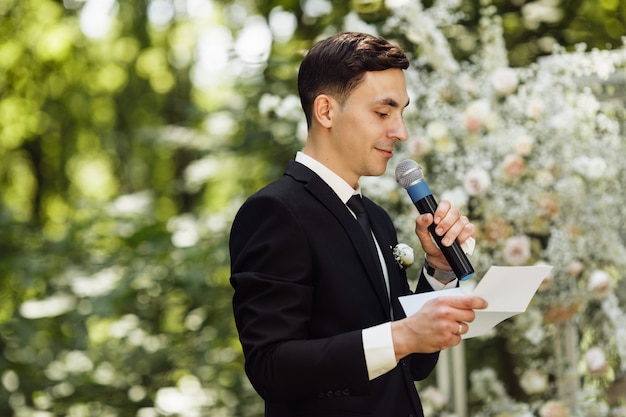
xmin=285 ymin=161 xmax=389 ymax=315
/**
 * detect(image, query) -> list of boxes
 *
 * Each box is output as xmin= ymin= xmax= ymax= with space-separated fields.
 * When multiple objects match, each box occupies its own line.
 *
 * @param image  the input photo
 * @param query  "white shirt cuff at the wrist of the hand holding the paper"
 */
xmin=362 ymin=322 xmax=397 ymax=381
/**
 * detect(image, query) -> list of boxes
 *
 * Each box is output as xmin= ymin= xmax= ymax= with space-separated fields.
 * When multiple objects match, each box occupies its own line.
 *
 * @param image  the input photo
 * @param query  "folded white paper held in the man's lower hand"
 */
xmin=399 ymin=265 xmax=552 ymax=339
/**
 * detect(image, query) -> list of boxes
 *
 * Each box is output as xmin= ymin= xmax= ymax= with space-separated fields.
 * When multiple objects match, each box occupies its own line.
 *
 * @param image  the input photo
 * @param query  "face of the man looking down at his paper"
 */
xmin=330 ymin=69 xmax=409 ymax=185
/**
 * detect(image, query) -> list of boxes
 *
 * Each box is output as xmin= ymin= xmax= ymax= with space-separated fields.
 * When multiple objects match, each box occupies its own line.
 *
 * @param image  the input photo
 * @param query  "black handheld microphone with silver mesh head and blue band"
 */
xmin=396 ymin=159 xmax=474 ymax=281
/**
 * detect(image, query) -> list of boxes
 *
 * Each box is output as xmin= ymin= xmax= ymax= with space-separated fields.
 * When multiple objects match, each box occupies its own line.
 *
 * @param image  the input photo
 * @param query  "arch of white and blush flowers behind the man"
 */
xmin=345 ymin=1 xmax=626 ymax=417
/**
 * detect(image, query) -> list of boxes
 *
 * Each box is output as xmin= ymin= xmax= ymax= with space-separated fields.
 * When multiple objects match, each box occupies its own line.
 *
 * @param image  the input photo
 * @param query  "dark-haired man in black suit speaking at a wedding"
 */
xmin=230 ymin=33 xmax=486 ymax=417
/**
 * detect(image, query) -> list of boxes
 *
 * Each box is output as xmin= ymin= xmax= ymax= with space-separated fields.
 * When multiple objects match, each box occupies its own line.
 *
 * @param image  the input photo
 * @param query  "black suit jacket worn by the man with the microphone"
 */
xmin=230 ymin=161 xmax=438 ymax=417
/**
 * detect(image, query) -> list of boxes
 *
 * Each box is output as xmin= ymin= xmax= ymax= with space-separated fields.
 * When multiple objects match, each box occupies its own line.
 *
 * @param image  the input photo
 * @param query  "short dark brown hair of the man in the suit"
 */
xmin=298 ymin=32 xmax=409 ymax=127
